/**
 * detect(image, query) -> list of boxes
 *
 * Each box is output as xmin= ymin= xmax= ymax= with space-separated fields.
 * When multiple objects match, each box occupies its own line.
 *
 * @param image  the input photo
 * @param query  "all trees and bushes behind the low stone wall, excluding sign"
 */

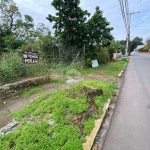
xmin=0 ymin=0 xmax=128 ymax=84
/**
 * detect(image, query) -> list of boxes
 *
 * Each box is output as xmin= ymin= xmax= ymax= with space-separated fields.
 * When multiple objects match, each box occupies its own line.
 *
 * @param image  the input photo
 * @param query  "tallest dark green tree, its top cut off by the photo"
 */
xmin=47 ymin=0 xmax=90 ymax=47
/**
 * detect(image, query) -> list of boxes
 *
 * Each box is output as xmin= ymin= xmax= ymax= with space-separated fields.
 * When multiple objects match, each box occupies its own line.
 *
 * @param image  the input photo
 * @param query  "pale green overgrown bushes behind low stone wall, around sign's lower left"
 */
xmin=0 ymin=51 xmax=48 ymax=84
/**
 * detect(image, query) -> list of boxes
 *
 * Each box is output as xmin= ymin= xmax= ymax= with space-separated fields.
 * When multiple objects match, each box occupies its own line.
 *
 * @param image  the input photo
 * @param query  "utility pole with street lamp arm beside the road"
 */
xmin=126 ymin=11 xmax=140 ymax=56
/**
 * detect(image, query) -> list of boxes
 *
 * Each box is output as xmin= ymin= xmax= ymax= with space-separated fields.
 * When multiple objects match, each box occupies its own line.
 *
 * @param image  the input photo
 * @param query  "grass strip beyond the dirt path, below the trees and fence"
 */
xmin=50 ymin=59 xmax=128 ymax=83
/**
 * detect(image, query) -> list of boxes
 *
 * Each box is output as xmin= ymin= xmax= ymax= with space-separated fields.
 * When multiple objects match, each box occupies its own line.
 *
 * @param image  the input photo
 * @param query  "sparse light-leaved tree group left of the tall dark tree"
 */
xmin=0 ymin=0 xmax=49 ymax=53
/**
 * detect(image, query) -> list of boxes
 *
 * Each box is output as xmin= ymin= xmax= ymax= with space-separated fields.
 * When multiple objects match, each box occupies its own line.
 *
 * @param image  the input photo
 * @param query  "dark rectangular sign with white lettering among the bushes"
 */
xmin=22 ymin=51 xmax=39 ymax=64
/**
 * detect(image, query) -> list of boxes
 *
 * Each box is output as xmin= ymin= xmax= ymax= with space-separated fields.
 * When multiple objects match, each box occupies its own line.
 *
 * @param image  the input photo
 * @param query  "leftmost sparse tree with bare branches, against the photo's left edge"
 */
xmin=0 ymin=0 xmax=22 ymax=53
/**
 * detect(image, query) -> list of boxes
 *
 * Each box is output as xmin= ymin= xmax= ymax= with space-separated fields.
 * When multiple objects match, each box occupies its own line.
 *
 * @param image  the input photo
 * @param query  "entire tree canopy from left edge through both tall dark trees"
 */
xmin=0 ymin=0 xmax=116 ymax=66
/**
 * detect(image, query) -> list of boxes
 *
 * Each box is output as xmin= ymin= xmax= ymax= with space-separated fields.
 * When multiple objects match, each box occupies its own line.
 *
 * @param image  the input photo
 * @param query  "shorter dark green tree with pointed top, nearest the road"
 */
xmin=87 ymin=6 xmax=113 ymax=47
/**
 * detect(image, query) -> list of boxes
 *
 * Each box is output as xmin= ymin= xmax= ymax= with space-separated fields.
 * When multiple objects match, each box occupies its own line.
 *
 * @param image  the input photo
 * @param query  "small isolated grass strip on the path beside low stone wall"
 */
xmin=21 ymin=88 xmax=43 ymax=98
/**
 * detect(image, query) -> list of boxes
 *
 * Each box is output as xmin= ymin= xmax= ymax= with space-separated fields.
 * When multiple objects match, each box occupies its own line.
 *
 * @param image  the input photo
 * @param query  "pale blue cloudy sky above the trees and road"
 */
xmin=14 ymin=0 xmax=150 ymax=43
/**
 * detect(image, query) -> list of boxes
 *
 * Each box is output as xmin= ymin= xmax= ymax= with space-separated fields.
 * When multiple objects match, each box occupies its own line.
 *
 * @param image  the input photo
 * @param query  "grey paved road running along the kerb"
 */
xmin=103 ymin=55 xmax=150 ymax=150
